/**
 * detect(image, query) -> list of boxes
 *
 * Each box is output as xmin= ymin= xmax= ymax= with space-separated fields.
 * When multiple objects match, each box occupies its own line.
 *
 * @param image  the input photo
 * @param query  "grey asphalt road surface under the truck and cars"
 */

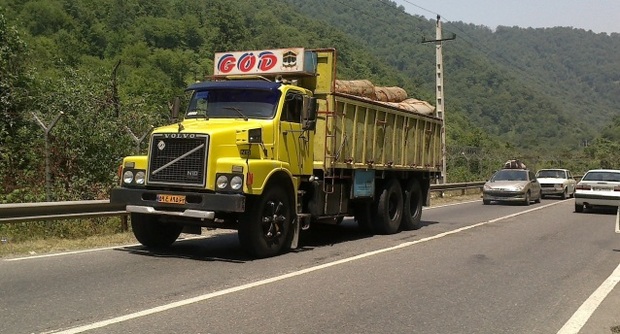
xmin=0 ymin=199 xmax=620 ymax=334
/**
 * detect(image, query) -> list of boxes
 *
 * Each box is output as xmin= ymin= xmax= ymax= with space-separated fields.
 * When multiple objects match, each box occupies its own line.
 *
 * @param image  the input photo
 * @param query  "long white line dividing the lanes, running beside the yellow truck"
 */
xmin=50 ymin=202 xmax=558 ymax=334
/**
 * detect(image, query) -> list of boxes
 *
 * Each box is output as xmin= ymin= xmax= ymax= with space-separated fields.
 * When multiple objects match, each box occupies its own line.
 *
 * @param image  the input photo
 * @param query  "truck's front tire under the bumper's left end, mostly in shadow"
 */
xmin=131 ymin=213 xmax=183 ymax=248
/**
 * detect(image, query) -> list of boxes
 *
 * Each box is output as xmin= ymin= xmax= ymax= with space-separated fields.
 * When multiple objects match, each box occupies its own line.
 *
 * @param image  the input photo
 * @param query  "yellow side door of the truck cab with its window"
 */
xmin=278 ymin=90 xmax=314 ymax=175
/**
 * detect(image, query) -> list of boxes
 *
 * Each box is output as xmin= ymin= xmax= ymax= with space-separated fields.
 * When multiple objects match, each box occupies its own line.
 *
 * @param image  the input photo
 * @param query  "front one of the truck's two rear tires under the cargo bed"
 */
xmin=373 ymin=178 xmax=404 ymax=234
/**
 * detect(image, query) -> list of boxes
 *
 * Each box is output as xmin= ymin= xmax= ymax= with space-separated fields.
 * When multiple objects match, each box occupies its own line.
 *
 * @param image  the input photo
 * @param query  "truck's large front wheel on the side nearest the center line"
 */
xmin=239 ymin=186 xmax=293 ymax=258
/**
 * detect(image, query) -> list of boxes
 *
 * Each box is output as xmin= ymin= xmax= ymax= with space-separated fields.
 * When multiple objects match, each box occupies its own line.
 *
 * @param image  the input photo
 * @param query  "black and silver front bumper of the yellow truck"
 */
xmin=110 ymin=188 xmax=245 ymax=220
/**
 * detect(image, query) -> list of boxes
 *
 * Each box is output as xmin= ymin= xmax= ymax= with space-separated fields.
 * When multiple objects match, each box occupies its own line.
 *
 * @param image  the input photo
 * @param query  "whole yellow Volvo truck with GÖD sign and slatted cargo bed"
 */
xmin=110 ymin=48 xmax=442 ymax=258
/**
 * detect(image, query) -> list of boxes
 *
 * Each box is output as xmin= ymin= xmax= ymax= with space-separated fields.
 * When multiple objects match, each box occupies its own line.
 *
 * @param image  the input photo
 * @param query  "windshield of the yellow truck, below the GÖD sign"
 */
xmin=186 ymin=89 xmax=280 ymax=119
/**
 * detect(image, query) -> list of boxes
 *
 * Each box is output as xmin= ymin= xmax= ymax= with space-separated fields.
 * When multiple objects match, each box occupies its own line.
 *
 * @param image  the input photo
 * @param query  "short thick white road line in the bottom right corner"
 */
xmin=558 ymin=265 xmax=620 ymax=334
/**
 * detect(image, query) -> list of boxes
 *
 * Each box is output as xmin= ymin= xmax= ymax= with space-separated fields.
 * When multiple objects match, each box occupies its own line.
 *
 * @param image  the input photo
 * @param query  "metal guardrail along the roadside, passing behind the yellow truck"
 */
xmin=0 ymin=181 xmax=484 ymax=224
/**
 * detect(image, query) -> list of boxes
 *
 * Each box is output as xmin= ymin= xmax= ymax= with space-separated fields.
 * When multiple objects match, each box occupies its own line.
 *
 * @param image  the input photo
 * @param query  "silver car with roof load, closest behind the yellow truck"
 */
xmin=482 ymin=169 xmax=542 ymax=205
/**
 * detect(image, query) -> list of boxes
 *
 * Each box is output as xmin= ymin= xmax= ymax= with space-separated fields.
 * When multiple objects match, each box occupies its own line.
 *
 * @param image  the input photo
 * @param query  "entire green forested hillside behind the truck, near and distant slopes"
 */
xmin=0 ymin=0 xmax=620 ymax=202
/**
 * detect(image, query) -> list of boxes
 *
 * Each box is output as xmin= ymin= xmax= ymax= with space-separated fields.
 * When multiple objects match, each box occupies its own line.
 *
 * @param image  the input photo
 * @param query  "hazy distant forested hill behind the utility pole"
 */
xmin=287 ymin=0 xmax=620 ymax=153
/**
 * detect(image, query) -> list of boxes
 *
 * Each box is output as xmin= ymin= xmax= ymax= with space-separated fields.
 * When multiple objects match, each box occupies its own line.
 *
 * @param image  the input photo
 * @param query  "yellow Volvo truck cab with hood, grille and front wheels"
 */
xmin=111 ymin=50 xmax=317 ymax=257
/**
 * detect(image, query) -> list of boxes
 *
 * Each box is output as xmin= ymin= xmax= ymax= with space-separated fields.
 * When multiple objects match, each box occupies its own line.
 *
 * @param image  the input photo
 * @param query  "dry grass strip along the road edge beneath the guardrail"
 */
xmin=0 ymin=190 xmax=480 ymax=258
